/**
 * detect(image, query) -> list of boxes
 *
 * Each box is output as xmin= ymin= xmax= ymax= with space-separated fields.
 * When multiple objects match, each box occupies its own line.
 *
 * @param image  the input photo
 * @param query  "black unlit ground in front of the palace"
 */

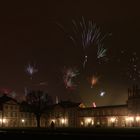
xmin=0 ymin=128 xmax=140 ymax=140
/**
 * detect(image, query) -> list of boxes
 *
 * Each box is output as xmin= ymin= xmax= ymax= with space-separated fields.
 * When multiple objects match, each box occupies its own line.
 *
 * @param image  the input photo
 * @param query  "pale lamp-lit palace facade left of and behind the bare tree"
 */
xmin=0 ymin=101 xmax=45 ymax=127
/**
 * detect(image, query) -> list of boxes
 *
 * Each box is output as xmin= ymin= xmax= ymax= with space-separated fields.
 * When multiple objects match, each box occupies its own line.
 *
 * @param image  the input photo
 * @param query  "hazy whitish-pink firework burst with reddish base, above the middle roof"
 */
xmin=63 ymin=68 xmax=79 ymax=89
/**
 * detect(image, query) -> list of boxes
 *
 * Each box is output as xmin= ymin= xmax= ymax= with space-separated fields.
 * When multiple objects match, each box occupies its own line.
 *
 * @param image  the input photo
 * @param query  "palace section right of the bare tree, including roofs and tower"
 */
xmin=49 ymin=86 xmax=140 ymax=127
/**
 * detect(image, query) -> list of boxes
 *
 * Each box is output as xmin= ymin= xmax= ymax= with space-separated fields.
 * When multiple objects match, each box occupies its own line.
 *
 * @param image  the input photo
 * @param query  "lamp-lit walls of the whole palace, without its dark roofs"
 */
xmin=0 ymin=102 xmax=140 ymax=127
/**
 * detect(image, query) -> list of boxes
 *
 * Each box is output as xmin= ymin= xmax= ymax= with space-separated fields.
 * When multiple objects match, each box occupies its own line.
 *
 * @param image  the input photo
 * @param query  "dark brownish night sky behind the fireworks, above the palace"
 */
xmin=0 ymin=0 xmax=140 ymax=106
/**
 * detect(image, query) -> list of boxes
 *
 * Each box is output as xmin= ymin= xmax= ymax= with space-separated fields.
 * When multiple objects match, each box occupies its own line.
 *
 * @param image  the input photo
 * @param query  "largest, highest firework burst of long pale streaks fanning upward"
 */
xmin=72 ymin=17 xmax=101 ymax=50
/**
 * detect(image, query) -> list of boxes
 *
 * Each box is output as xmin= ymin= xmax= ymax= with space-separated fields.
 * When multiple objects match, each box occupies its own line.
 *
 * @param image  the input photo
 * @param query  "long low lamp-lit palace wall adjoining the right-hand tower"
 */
xmin=79 ymin=106 xmax=128 ymax=127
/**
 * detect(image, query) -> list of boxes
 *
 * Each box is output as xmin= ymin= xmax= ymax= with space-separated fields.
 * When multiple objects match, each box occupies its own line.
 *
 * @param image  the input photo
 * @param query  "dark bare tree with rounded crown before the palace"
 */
xmin=26 ymin=90 xmax=52 ymax=127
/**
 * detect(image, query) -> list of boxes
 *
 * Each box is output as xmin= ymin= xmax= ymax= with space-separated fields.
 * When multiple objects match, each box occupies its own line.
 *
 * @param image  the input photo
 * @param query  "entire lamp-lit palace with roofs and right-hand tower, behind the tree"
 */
xmin=0 ymin=86 xmax=140 ymax=127
